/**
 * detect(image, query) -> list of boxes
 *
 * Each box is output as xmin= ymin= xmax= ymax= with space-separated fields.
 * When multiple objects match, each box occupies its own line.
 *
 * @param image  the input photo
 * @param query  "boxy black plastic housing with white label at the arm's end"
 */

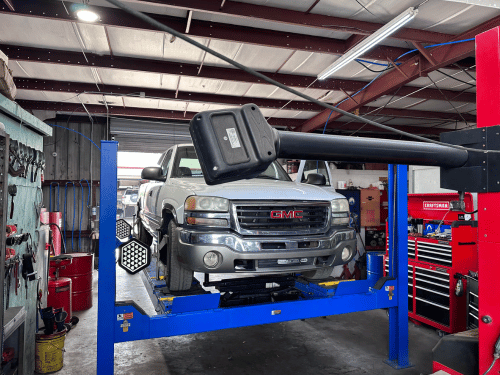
xmin=189 ymin=104 xmax=277 ymax=185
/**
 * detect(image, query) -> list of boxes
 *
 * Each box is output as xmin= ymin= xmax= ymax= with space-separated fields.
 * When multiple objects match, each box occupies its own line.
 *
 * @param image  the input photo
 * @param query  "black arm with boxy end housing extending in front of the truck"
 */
xmin=189 ymin=104 xmax=469 ymax=185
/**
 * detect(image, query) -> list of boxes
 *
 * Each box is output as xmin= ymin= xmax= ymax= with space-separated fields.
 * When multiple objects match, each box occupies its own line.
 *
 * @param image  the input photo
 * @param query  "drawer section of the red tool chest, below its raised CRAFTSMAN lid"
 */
xmin=384 ymin=221 xmax=477 ymax=333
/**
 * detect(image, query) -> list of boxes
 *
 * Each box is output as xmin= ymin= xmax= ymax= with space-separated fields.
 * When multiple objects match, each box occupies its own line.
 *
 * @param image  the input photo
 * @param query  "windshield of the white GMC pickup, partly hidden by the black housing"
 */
xmin=172 ymin=146 xmax=291 ymax=181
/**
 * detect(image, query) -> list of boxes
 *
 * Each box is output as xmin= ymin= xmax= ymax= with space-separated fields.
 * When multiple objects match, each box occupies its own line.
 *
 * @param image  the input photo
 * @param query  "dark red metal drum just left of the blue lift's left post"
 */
xmin=59 ymin=253 xmax=94 ymax=311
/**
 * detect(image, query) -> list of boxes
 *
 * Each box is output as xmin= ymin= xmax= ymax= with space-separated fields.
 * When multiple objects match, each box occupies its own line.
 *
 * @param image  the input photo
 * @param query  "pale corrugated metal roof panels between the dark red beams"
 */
xmin=0 ymin=0 xmax=490 ymax=144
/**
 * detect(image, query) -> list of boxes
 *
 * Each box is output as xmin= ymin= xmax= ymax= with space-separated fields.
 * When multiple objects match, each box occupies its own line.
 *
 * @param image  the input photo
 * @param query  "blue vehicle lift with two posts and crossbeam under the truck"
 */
xmin=97 ymin=141 xmax=412 ymax=375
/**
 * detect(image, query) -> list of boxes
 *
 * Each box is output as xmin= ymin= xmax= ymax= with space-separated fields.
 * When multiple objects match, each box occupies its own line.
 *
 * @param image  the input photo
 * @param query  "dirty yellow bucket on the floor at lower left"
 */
xmin=35 ymin=329 xmax=66 ymax=374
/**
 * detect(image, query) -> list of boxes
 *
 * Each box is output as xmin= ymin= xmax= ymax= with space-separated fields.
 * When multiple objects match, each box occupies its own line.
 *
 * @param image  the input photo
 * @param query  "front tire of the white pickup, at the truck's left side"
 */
xmin=167 ymin=220 xmax=193 ymax=292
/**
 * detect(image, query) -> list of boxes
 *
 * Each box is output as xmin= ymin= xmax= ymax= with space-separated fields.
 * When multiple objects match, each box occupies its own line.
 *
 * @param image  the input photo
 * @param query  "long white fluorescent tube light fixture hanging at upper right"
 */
xmin=318 ymin=8 xmax=418 ymax=79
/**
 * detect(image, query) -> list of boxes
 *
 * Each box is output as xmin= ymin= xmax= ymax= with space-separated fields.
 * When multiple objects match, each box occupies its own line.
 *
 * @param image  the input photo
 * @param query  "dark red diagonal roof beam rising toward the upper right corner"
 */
xmin=300 ymin=17 xmax=500 ymax=132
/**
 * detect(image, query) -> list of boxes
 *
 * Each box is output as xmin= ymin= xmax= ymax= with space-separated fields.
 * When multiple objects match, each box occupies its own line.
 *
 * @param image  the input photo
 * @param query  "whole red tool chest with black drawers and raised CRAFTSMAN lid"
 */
xmin=384 ymin=194 xmax=478 ymax=333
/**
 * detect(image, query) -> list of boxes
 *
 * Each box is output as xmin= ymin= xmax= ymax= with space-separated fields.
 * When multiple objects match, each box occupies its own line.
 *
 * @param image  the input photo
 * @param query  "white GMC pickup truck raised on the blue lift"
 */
xmin=134 ymin=144 xmax=356 ymax=291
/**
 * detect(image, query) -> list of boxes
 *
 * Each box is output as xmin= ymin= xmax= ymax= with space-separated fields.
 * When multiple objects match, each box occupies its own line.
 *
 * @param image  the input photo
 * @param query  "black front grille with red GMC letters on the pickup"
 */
xmin=234 ymin=202 xmax=330 ymax=233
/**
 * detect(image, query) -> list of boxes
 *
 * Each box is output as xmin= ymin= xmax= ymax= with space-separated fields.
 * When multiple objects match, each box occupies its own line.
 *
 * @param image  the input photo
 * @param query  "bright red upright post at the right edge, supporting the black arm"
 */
xmin=474 ymin=27 xmax=500 ymax=374
